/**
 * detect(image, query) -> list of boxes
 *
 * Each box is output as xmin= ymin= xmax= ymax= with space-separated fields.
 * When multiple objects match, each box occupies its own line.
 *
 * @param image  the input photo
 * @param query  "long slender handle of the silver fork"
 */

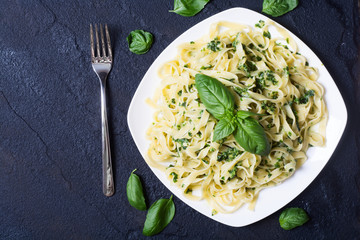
xmin=99 ymin=74 xmax=115 ymax=197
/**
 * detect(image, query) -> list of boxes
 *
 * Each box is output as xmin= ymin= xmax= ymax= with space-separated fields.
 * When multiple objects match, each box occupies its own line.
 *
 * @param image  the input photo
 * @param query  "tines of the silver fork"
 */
xmin=90 ymin=24 xmax=112 ymax=62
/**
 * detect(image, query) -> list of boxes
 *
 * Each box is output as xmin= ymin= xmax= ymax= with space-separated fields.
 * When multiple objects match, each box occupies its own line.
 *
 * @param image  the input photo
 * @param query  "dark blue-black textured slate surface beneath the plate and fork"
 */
xmin=0 ymin=0 xmax=360 ymax=240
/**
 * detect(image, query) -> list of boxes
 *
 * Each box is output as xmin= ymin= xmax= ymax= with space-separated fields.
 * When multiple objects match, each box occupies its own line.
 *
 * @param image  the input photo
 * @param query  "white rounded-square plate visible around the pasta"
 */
xmin=128 ymin=8 xmax=347 ymax=227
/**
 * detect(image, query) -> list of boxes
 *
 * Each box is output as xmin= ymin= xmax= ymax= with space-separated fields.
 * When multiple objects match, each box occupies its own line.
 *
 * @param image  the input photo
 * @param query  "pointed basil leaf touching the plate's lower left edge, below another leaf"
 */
xmin=143 ymin=195 xmax=175 ymax=236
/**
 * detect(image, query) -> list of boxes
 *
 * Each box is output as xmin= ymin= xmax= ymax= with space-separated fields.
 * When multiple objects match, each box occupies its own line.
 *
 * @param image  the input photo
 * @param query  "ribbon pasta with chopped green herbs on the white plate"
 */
xmin=146 ymin=21 xmax=327 ymax=213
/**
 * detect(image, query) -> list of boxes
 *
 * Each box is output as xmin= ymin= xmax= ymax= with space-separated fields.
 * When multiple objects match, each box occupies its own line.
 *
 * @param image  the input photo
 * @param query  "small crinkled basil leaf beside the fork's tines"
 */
xmin=126 ymin=30 xmax=154 ymax=54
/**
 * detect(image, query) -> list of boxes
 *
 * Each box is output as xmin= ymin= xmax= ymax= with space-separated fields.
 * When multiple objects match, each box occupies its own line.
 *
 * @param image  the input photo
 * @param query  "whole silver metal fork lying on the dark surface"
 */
xmin=90 ymin=24 xmax=114 ymax=197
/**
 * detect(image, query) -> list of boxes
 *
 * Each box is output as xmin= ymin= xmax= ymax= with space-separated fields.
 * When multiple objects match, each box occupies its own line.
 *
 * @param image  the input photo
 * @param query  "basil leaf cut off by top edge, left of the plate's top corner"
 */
xmin=170 ymin=0 xmax=210 ymax=17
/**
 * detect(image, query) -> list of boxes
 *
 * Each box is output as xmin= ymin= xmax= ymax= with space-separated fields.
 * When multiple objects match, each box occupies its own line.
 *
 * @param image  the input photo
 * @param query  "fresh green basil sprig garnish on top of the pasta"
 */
xmin=195 ymin=74 xmax=270 ymax=155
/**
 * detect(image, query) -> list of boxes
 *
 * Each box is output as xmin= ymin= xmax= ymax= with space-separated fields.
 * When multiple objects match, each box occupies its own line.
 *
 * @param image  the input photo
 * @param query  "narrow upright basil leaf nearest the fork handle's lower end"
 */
xmin=126 ymin=169 xmax=146 ymax=211
